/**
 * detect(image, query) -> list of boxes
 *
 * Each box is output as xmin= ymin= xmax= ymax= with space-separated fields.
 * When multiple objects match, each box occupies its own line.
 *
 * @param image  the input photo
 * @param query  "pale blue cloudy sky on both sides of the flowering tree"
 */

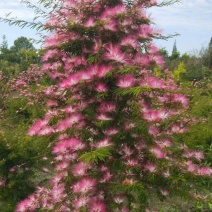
xmin=0 ymin=0 xmax=212 ymax=54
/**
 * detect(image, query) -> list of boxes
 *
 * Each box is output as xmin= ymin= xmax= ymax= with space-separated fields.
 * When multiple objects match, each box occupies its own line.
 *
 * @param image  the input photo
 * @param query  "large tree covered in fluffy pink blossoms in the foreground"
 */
xmin=12 ymin=0 xmax=212 ymax=212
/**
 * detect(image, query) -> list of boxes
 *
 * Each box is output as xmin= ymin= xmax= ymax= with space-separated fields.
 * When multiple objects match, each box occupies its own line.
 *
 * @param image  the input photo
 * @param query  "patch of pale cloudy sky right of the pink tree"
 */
xmin=150 ymin=0 xmax=212 ymax=52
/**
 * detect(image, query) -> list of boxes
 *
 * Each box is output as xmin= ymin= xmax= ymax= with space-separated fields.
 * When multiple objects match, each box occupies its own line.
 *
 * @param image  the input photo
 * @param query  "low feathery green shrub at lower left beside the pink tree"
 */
xmin=0 ymin=113 xmax=49 ymax=212
